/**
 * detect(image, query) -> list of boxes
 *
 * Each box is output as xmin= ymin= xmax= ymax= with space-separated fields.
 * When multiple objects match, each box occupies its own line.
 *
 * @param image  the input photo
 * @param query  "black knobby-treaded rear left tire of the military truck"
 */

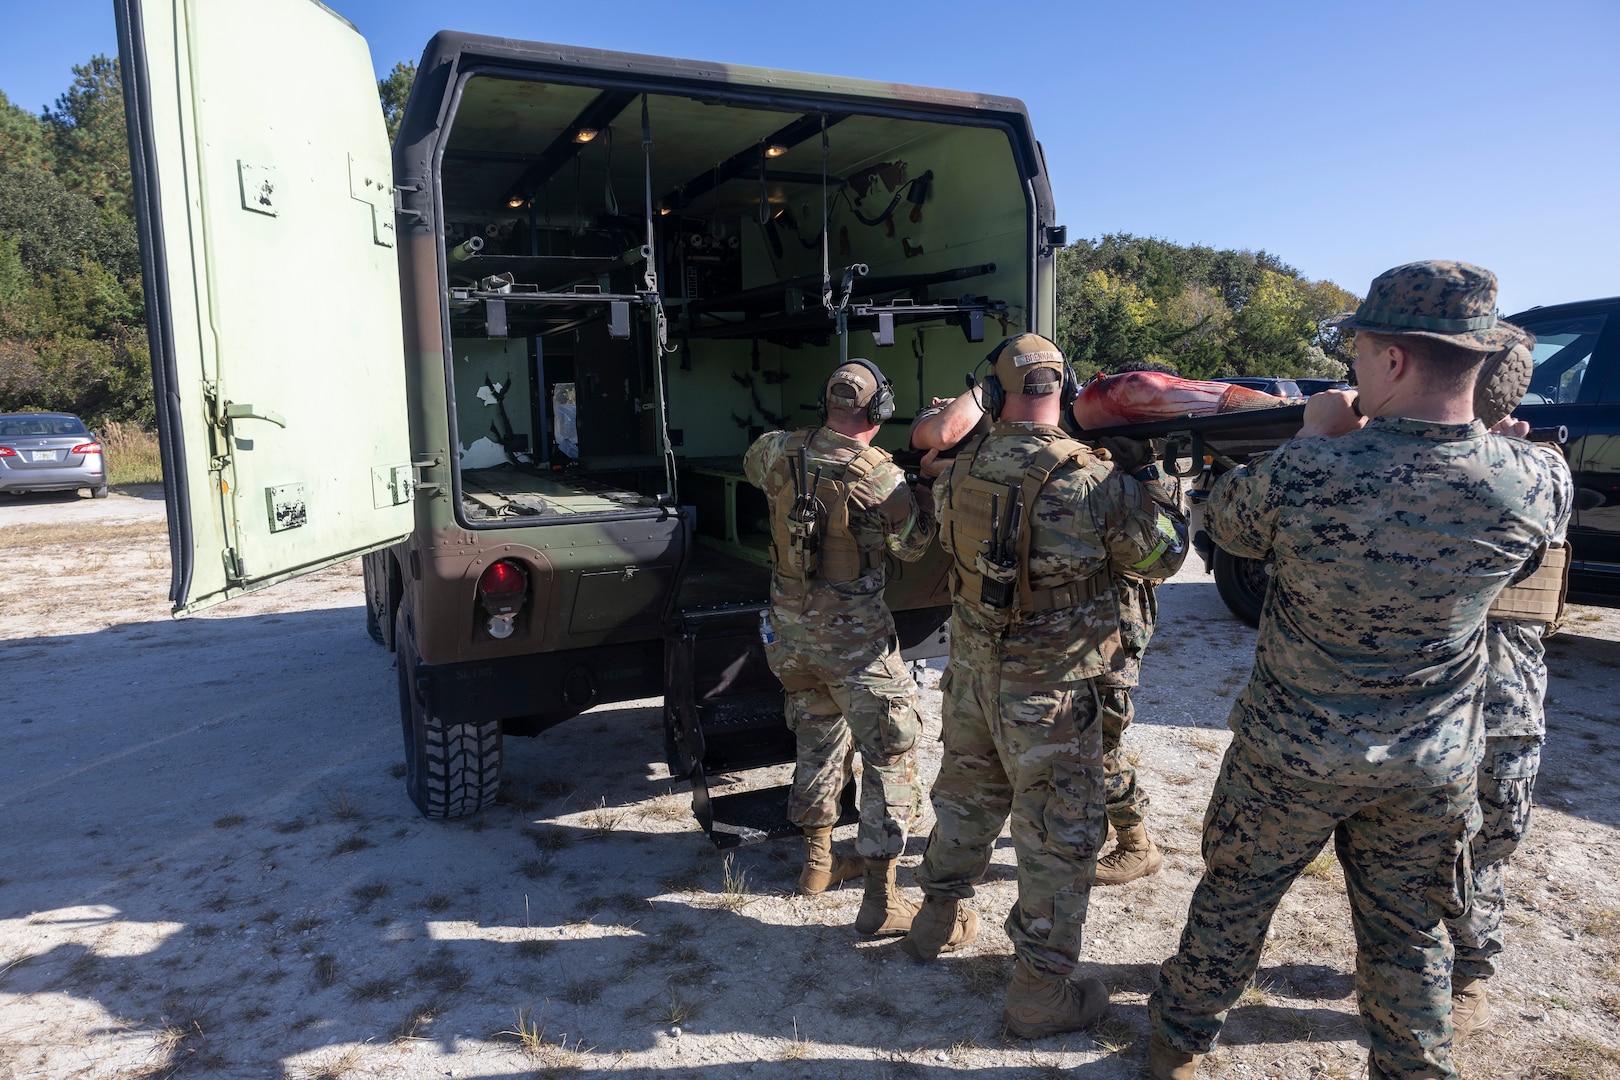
xmin=394 ymin=607 xmax=501 ymax=818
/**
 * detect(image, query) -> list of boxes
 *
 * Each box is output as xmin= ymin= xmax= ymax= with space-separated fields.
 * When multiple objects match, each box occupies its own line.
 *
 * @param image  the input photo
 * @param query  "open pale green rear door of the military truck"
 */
xmin=117 ymin=0 xmax=413 ymax=614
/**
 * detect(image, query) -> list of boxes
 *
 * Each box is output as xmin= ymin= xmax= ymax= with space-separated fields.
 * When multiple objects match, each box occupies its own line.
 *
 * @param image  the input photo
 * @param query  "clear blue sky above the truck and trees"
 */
xmin=0 ymin=0 xmax=1620 ymax=311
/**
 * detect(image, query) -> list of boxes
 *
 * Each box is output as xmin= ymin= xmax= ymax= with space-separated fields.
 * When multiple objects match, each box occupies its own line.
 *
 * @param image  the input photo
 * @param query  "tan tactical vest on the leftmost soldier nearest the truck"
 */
xmin=771 ymin=427 xmax=889 ymax=586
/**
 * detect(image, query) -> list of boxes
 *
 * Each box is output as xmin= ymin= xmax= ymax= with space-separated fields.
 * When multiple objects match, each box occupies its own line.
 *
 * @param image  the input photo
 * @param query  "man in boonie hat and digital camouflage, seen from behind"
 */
xmin=1149 ymin=262 xmax=1567 ymax=1080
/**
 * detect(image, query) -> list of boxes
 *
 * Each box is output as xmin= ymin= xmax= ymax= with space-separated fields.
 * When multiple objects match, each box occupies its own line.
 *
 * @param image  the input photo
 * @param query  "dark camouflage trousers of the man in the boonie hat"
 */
xmin=1149 ymin=740 xmax=1479 ymax=1080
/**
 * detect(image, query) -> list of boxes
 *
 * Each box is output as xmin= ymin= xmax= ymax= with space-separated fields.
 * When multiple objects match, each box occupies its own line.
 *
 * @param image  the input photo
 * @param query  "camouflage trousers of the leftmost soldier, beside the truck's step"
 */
xmin=765 ymin=636 xmax=922 ymax=858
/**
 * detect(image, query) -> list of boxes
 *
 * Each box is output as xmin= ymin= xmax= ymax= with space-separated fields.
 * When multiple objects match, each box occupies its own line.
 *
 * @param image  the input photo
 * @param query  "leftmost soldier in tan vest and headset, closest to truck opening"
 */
xmin=744 ymin=359 xmax=936 ymax=934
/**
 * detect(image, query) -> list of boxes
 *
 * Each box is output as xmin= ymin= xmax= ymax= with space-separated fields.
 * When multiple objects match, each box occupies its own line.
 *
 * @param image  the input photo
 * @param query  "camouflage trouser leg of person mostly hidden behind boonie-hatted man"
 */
xmin=1445 ymin=735 xmax=1542 ymax=978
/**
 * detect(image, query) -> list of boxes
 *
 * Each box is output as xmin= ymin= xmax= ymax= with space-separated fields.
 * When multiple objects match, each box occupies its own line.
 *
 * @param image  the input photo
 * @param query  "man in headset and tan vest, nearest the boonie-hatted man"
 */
xmin=901 ymin=334 xmax=1186 ymax=1038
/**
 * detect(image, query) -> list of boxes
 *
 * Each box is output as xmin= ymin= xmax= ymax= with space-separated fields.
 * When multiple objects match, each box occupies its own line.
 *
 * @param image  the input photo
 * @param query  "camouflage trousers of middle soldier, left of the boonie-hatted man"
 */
xmin=917 ymin=665 xmax=1105 ymax=978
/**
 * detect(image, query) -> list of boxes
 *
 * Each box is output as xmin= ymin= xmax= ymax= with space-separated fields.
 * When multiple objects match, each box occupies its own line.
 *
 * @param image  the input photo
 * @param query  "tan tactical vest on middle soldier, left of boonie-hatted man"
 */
xmin=940 ymin=436 xmax=1110 ymax=625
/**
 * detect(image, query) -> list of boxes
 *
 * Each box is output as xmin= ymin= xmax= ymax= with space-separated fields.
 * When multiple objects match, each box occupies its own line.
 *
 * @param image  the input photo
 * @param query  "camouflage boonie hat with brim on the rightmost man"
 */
xmin=1328 ymin=259 xmax=1524 ymax=353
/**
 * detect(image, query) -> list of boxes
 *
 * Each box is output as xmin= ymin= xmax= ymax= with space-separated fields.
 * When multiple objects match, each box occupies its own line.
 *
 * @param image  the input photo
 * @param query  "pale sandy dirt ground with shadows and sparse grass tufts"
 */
xmin=0 ymin=521 xmax=1620 ymax=1080
